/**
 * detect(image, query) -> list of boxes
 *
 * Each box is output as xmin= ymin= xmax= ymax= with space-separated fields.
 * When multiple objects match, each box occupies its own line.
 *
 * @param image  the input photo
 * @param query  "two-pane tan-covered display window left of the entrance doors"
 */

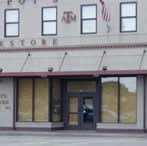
xmin=17 ymin=78 xmax=49 ymax=122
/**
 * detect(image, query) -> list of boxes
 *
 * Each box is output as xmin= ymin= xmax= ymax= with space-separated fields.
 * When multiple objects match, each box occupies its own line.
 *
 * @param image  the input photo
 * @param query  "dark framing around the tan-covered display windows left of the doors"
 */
xmin=15 ymin=77 xmax=63 ymax=123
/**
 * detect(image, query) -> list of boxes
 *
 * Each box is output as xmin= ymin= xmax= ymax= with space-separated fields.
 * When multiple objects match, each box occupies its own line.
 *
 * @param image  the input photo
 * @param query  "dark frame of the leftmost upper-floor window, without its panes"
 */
xmin=4 ymin=8 xmax=20 ymax=38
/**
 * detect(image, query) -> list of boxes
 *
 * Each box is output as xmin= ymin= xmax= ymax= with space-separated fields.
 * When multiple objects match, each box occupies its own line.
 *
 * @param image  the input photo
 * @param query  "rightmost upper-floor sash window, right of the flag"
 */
xmin=120 ymin=2 xmax=137 ymax=32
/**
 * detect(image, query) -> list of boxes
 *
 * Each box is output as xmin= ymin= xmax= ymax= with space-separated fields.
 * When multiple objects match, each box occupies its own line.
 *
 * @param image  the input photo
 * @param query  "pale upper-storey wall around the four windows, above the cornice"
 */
xmin=0 ymin=0 xmax=147 ymax=48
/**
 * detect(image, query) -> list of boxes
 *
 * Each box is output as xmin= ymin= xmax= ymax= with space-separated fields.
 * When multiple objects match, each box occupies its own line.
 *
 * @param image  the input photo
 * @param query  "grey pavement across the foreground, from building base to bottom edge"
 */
xmin=0 ymin=132 xmax=147 ymax=146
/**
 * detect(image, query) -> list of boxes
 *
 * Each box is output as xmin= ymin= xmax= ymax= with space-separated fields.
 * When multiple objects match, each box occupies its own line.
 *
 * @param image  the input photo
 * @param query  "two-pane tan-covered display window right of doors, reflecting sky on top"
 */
xmin=101 ymin=77 xmax=137 ymax=123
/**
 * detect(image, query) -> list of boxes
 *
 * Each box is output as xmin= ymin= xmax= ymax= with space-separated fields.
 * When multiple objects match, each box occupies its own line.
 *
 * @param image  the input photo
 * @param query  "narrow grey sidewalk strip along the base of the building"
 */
xmin=0 ymin=130 xmax=147 ymax=138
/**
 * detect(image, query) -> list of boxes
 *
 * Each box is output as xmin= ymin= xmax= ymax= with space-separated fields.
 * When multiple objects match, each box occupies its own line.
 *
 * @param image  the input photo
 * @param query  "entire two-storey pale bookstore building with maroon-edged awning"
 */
xmin=0 ymin=0 xmax=147 ymax=132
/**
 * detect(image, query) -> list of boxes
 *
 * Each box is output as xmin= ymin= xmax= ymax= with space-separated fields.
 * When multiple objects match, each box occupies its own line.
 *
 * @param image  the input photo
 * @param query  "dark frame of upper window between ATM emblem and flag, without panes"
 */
xmin=81 ymin=4 xmax=97 ymax=35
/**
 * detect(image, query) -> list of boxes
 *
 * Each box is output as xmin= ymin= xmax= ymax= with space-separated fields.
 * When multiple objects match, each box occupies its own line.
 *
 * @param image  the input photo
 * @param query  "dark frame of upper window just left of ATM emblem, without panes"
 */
xmin=41 ymin=6 xmax=58 ymax=36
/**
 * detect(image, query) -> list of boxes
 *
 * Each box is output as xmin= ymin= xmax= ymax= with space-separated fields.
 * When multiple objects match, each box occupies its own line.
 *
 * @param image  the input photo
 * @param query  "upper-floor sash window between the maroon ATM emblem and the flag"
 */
xmin=81 ymin=4 xmax=97 ymax=34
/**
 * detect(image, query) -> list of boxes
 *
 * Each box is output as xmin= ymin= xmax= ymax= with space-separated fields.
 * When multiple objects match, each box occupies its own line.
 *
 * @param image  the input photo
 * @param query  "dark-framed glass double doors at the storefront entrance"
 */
xmin=67 ymin=94 xmax=95 ymax=130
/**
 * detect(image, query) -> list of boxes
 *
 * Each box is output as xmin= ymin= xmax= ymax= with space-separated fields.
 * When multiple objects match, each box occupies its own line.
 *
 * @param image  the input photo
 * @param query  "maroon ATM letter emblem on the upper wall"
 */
xmin=62 ymin=11 xmax=76 ymax=23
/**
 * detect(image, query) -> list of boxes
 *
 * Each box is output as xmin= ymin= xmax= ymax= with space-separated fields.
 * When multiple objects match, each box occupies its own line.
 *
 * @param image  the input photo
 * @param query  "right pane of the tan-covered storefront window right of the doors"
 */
xmin=120 ymin=77 xmax=137 ymax=123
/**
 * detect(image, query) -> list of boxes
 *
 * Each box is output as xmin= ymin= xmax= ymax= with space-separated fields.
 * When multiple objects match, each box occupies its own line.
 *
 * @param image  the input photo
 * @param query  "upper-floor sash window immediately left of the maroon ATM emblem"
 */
xmin=42 ymin=7 xmax=57 ymax=35
